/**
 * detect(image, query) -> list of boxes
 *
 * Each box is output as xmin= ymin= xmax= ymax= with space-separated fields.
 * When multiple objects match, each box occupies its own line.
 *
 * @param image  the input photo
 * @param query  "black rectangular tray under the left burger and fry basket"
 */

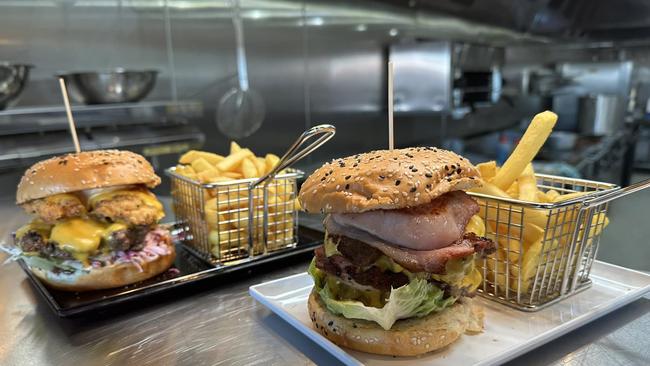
xmin=18 ymin=227 xmax=323 ymax=317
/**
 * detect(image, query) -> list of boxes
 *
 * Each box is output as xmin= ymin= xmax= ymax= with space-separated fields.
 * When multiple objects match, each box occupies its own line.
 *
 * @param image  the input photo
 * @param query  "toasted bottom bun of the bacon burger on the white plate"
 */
xmin=307 ymin=291 xmax=483 ymax=356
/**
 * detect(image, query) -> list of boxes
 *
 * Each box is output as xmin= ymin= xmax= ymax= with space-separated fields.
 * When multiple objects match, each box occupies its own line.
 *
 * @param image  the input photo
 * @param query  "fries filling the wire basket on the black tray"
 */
xmin=176 ymin=141 xmax=300 ymax=258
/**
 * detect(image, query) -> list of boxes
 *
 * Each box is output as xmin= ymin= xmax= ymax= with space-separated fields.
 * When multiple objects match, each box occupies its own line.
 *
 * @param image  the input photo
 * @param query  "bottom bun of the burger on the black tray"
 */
xmin=31 ymin=243 xmax=176 ymax=291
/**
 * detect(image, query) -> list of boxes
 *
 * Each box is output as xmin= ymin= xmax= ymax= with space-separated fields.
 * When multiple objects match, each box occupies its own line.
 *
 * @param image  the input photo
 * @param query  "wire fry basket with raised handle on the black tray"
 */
xmin=166 ymin=125 xmax=336 ymax=267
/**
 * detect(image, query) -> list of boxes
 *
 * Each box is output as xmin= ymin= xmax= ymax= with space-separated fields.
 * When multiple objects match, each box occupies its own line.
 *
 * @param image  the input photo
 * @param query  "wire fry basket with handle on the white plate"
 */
xmin=470 ymin=174 xmax=650 ymax=311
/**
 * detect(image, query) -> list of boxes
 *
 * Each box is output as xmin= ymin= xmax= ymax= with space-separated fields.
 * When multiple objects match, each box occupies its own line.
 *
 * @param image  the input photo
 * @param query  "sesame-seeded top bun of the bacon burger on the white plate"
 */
xmin=298 ymin=147 xmax=480 ymax=213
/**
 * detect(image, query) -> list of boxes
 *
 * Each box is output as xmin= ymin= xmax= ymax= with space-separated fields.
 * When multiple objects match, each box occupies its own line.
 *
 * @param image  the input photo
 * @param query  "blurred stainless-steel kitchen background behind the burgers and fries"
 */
xmin=0 ymin=0 xmax=650 ymax=270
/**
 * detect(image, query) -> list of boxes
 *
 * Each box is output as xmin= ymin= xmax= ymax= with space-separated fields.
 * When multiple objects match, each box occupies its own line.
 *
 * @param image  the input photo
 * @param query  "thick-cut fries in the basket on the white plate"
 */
xmin=467 ymin=111 xmax=609 ymax=294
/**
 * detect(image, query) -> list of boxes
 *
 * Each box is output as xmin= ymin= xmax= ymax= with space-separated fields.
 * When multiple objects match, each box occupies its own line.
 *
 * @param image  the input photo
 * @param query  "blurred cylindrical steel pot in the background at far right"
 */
xmin=578 ymin=94 xmax=623 ymax=136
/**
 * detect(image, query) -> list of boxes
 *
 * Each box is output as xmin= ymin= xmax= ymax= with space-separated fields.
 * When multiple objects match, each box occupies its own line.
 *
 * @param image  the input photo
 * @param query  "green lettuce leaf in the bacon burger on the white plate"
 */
xmin=309 ymin=261 xmax=456 ymax=330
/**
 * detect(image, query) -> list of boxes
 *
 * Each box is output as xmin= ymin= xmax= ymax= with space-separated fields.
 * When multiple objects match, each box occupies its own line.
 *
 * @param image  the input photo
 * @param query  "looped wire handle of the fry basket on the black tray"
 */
xmin=250 ymin=125 xmax=336 ymax=189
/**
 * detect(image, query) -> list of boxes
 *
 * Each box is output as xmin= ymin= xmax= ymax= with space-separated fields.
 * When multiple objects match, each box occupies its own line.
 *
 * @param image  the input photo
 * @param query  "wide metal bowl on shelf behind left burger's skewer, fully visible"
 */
xmin=58 ymin=69 xmax=158 ymax=104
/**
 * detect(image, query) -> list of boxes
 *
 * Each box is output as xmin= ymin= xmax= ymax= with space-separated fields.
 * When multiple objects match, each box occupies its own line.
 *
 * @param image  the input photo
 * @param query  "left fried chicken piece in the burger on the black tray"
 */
xmin=22 ymin=193 xmax=86 ymax=224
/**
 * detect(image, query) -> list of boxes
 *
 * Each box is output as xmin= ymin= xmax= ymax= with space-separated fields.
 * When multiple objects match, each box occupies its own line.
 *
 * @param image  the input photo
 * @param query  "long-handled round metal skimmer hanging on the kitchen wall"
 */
xmin=217 ymin=0 xmax=265 ymax=139
